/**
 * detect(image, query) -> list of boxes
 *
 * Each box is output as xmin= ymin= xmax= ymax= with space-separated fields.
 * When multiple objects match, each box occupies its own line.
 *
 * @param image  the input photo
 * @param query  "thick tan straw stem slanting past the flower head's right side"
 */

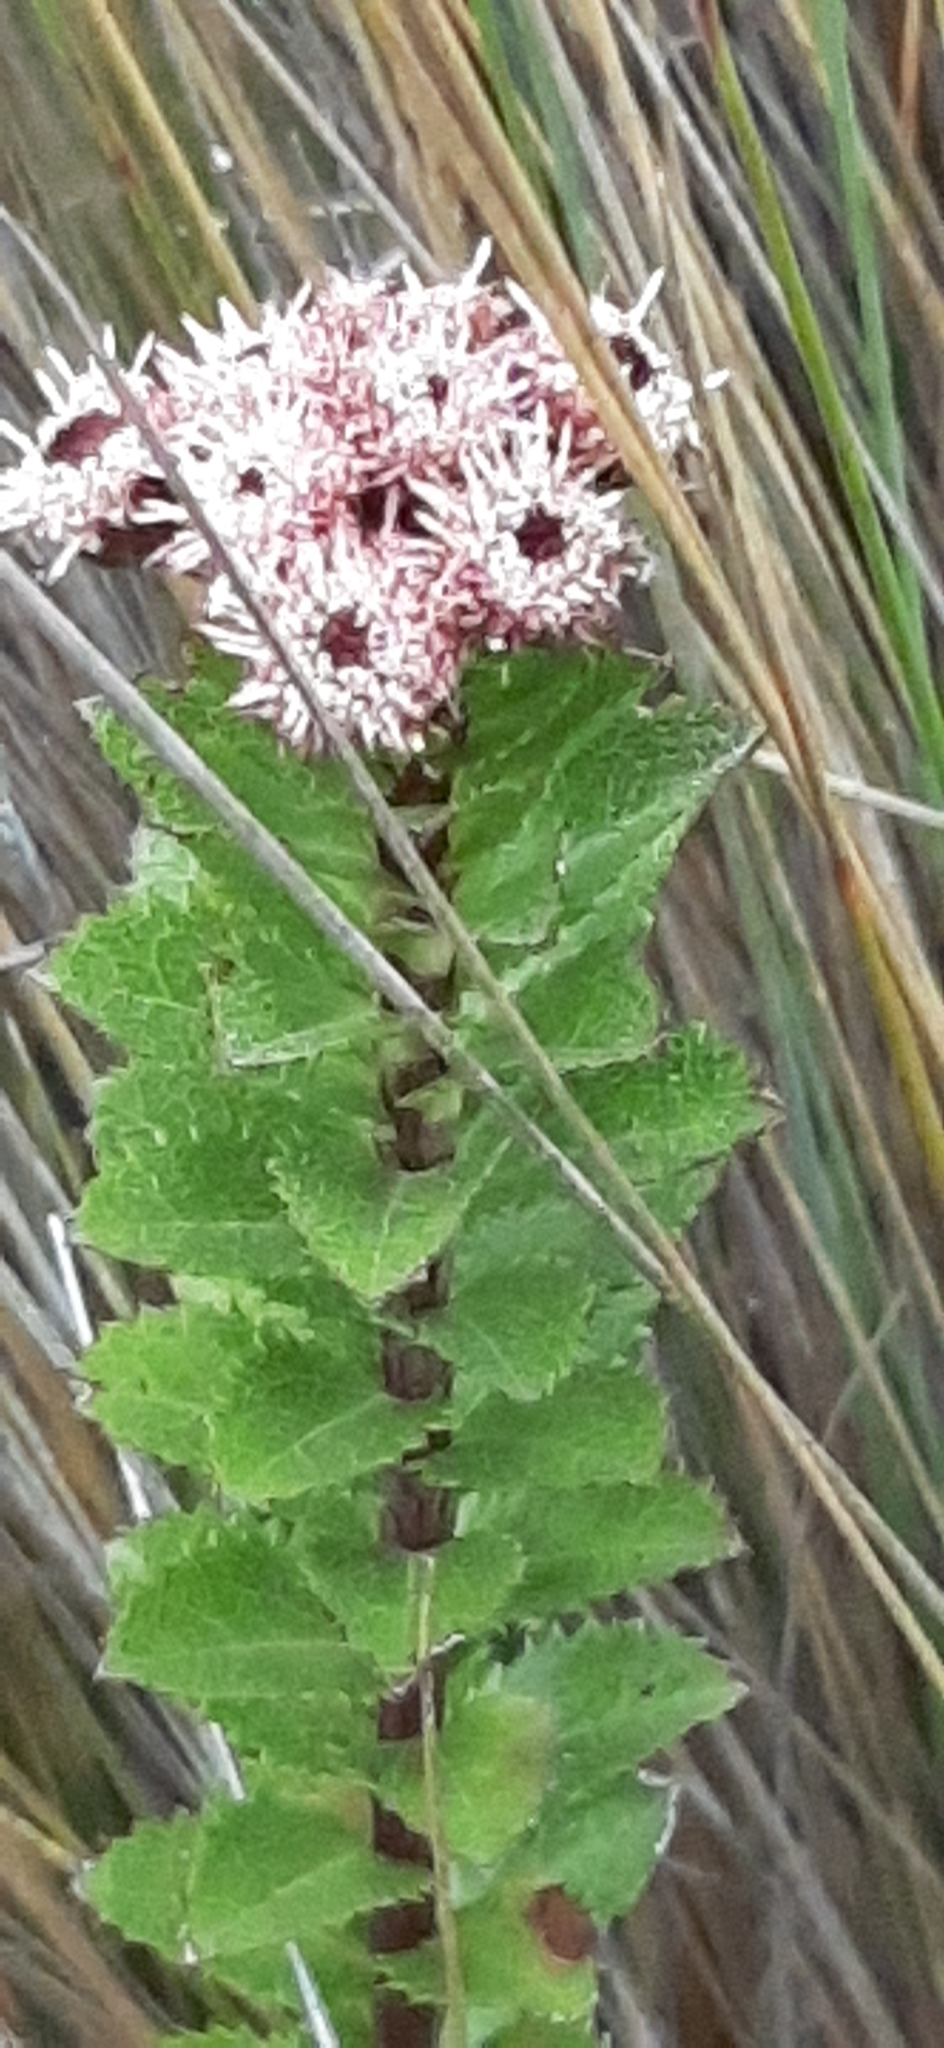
xmin=360 ymin=0 xmax=944 ymax=1190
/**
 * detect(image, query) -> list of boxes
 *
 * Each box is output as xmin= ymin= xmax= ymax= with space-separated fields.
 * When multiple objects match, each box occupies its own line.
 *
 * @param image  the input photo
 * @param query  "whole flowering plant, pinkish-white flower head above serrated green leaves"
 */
xmin=0 ymin=247 xmax=758 ymax=2048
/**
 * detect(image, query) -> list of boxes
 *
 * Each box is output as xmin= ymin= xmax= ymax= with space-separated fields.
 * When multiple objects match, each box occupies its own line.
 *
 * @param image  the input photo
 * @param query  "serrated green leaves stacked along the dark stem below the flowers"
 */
xmin=57 ymin=649 xmax=758 ymax=2048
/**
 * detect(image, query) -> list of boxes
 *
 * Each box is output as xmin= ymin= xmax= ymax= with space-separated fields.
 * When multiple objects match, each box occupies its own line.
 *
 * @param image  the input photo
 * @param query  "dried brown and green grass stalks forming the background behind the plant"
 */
xmin=0 ymin=0 xmax=944 ymax=2048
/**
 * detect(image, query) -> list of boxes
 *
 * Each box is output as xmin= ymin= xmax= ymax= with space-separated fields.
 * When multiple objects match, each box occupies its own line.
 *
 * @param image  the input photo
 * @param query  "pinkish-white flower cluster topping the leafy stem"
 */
xmin=0 ymin=252 xmax=698 ymax=752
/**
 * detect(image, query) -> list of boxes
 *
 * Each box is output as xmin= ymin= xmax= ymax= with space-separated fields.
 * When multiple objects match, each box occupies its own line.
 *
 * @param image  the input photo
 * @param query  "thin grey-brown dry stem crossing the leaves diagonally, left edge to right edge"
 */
xmin=0 ymin=557 xmax=944 ymax=1696
